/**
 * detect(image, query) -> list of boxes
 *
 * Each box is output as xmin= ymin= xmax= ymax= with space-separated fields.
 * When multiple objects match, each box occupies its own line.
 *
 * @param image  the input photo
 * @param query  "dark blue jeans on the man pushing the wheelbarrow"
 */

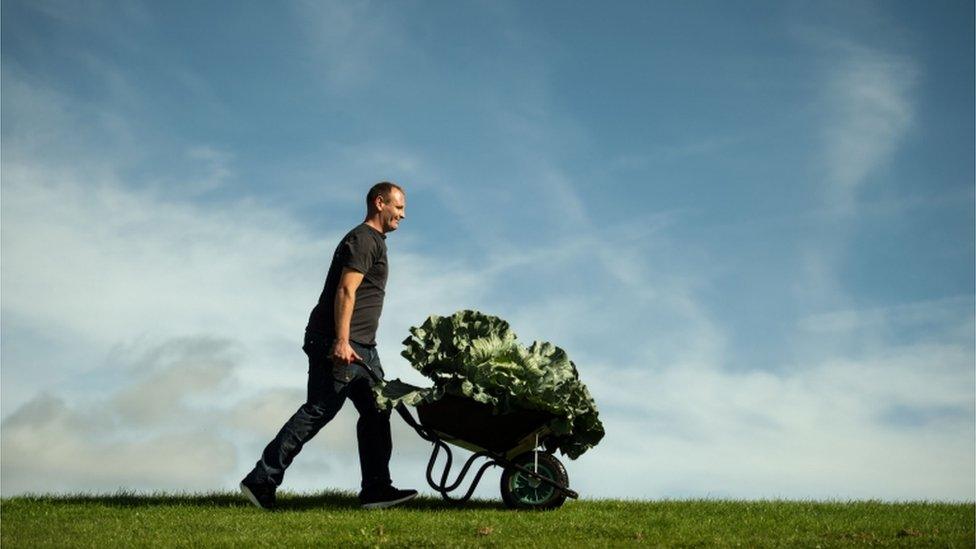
xmin=249 ymin=334 xmax=393 ymax=490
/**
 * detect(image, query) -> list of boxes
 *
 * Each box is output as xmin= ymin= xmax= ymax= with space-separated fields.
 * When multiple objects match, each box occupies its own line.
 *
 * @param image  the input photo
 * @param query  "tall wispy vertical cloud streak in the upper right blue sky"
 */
xmin=795 ymin=33 xmax=918 ymax=316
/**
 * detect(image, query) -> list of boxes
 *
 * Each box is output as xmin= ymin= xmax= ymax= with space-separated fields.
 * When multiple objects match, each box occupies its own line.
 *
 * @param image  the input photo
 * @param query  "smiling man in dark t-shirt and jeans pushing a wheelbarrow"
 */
xmin=241 ymin=181 xmax=417 ymax=509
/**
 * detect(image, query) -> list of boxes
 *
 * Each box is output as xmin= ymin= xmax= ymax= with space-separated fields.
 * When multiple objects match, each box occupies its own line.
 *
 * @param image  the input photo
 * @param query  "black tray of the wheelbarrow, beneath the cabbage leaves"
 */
xmin=417 ymin=394 xmax=555 ymax=458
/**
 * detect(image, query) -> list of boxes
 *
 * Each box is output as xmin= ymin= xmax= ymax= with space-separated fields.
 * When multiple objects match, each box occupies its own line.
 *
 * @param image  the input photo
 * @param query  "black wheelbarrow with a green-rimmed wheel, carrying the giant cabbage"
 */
xmin=366 ymin=368 xmax=579 ymax=510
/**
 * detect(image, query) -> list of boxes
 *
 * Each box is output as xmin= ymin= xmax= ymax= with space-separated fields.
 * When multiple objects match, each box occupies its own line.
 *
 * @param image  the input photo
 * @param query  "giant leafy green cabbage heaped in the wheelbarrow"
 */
xmin=377 ymin=310 xmax=604 ymax=459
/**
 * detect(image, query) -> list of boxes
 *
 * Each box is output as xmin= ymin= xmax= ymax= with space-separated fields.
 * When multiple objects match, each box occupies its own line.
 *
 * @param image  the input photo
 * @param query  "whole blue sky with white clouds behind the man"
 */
xmin=0 ymin=0 xmax=976 ymax=500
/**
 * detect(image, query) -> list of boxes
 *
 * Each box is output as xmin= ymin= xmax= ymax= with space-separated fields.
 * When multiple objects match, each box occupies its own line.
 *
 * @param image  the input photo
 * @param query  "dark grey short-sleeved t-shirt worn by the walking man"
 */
xmin=306 ymin=223 xmax=388 ymax=345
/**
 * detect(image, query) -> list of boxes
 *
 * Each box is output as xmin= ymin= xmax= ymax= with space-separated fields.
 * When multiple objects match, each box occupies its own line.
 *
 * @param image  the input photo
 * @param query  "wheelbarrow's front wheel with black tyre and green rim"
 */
xmin=501 ymin=452 xmax=569 ymax=510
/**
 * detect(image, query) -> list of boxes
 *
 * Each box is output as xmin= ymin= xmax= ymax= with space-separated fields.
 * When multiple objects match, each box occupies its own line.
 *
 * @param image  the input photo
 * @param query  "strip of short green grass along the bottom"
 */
xmin=0 ymin=492 xmax=976 ymax=549
